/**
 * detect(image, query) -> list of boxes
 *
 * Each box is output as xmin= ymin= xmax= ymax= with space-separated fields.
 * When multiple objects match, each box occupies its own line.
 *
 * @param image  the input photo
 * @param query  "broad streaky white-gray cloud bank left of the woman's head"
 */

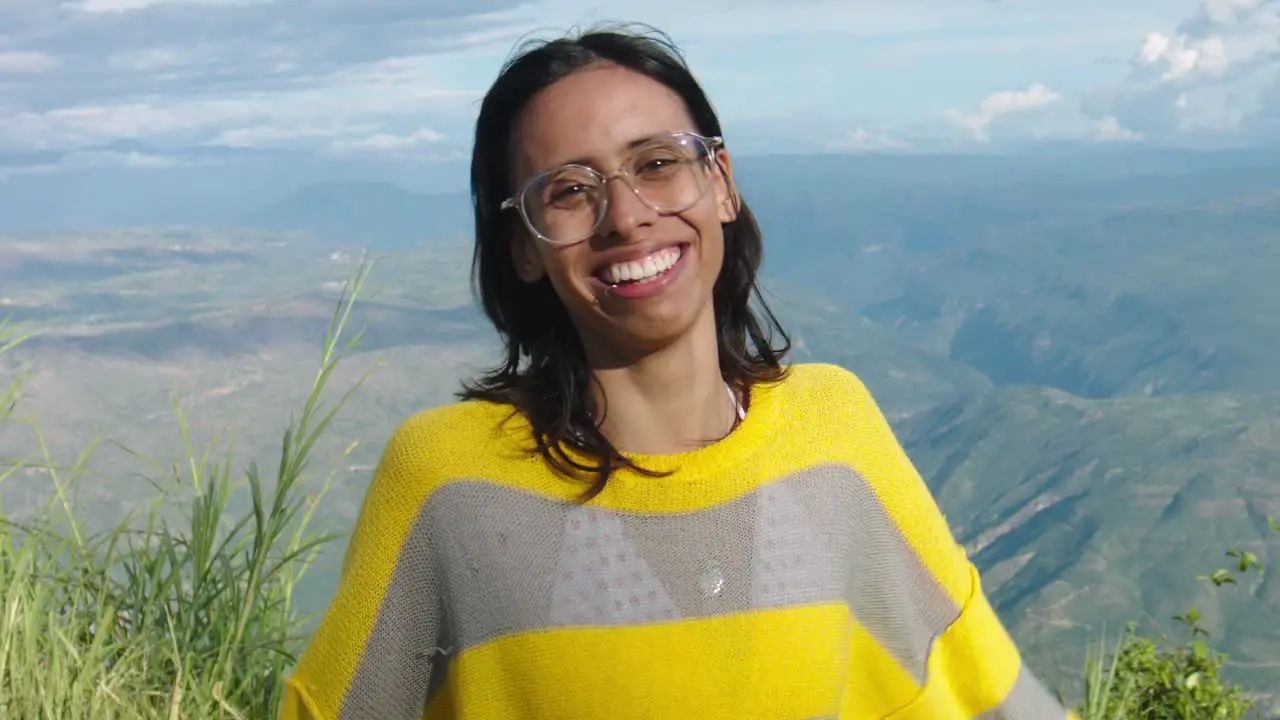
xmin=0 ymin=0 xmax=532 ymax=152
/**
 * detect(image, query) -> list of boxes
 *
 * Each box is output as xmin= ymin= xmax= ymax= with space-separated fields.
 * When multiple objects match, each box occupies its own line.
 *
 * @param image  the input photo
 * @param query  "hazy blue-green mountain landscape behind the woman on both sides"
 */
xmin=0 ymin=150 xmax=1280 ymax=702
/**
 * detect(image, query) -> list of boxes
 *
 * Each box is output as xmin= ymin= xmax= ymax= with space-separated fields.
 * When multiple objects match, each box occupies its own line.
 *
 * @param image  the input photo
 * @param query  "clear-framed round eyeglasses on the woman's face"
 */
xmin=500 ymin=132 xmax=723 ymax=245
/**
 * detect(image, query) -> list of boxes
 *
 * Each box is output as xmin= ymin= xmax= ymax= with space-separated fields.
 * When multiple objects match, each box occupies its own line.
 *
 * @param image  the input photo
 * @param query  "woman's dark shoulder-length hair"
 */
xmin=458 ymin=20 xmax=791 ymax=491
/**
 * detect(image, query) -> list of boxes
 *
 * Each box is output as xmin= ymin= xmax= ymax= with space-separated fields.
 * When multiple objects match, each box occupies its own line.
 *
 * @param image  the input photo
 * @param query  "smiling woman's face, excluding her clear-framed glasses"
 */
xmin=512 ymin=64 xmax=736 ymax=361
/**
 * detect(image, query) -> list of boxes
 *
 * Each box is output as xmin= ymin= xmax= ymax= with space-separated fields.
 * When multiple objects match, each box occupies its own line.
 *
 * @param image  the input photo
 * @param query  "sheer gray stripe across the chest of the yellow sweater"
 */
xmin=340 ymin=465 xmax=960 ymax=720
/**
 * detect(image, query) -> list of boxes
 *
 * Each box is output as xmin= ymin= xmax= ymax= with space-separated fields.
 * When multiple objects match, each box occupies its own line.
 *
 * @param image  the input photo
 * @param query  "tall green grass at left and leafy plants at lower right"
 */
xmin=0 ymin=258 xmax=1280 ymax=720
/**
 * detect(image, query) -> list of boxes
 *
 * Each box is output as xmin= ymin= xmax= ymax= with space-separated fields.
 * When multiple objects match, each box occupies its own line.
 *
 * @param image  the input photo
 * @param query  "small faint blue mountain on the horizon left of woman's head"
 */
xmin=242 ymin=182 xmax=474 ymax=250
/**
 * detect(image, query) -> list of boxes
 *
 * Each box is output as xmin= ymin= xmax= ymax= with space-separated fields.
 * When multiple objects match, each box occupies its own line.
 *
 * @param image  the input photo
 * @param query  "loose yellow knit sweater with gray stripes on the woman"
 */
xmin=283 ymin=365 xmax=1068 ymax=720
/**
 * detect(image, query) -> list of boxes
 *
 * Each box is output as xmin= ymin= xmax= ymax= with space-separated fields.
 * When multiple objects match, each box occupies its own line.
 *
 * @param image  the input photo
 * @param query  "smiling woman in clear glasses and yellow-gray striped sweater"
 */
xmin=284 ymin=23 xmax=1066 ymax=720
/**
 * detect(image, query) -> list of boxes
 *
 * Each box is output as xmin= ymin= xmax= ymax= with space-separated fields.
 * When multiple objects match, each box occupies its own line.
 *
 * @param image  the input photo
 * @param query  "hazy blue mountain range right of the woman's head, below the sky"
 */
xmin=744 ymin=159 xmax=1280 ymax=397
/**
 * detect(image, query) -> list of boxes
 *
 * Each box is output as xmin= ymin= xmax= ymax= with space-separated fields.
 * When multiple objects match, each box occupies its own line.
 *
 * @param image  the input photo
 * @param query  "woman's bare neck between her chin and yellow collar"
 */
xmin=593 ymin=308 xmax=737 ymax=455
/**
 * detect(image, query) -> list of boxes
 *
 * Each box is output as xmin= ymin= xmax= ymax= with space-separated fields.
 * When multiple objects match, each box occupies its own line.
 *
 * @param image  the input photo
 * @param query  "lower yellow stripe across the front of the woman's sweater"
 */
xmin=426 ymin=603 xmax=919 ymax=720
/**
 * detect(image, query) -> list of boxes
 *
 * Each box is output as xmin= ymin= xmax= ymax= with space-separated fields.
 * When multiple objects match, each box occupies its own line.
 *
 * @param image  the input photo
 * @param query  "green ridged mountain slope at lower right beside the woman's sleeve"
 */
xmin=896 ymin=387 xmax=1280 ymax=689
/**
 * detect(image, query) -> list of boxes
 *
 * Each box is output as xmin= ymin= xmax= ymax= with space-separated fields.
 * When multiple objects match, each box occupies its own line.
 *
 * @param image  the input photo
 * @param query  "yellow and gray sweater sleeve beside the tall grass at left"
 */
xmin=280 ymin=415 xmax=444 ymax=720
